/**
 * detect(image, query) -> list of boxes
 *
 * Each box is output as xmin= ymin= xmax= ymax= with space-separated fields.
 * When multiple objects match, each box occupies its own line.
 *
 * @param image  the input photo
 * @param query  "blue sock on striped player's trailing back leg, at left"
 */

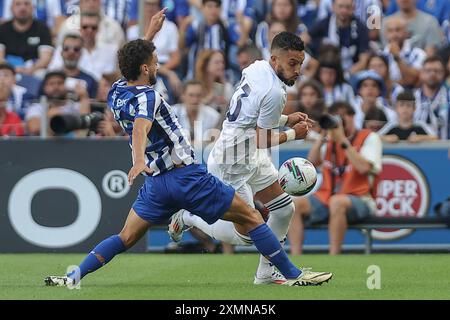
xmin=67 ymin=235 xmax=127 ymax=279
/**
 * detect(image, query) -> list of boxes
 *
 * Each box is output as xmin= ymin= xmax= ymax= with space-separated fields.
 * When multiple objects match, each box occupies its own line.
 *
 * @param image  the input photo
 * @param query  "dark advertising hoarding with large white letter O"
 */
xmin=0 ymin=139 xmax=146 ymax=253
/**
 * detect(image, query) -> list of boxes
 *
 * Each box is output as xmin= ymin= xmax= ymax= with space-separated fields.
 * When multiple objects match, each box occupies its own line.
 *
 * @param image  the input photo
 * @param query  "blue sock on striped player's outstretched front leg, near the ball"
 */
xmin=248 ymin=223 xmax=302 ymax=279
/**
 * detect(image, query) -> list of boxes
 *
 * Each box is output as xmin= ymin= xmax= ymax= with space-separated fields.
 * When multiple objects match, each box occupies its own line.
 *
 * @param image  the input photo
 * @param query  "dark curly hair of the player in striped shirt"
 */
xmin=117 ymin=39 xmax=155 ymax=81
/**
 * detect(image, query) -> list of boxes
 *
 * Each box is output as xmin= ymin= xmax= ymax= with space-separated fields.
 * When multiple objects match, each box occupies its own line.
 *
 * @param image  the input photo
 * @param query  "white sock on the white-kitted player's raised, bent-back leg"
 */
xmin=183 ymin=211 xmax=253 ymax=246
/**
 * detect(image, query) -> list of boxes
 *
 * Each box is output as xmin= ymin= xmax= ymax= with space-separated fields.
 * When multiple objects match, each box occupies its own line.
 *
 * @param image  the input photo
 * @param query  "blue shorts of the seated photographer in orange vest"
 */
xmin=306 ymin=195 xmax=370 ymax=224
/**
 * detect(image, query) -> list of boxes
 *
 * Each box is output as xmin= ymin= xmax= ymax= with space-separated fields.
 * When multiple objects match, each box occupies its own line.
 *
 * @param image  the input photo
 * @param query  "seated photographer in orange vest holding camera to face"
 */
xmin=288 ymin=102 xmax=382 ymax=254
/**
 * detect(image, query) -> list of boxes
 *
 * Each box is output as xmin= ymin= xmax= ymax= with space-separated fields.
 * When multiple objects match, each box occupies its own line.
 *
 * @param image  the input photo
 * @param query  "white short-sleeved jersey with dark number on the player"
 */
xmin=209 ymin=60 xmax=287 ymax=173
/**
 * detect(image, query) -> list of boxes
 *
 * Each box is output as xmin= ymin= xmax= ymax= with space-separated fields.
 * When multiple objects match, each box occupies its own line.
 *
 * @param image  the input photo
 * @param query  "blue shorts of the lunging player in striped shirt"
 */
xmin=133 ymin=164 xmax=235 ymax=224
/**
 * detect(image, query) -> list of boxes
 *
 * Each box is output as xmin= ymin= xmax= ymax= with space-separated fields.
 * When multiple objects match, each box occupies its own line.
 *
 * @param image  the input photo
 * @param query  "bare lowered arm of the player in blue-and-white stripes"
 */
xmin=128 ymin=118 xmax=153 ymax=186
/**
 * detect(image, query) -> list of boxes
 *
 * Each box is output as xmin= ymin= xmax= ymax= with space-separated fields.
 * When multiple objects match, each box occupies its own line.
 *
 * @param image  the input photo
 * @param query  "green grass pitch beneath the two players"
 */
xmin=0 ymin=254 xmax=450 ymax=300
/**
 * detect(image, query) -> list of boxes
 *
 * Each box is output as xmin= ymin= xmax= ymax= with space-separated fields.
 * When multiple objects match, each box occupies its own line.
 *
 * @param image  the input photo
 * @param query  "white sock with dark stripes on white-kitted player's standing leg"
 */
xmin=256 ymin=193 xmax=295 ymax=278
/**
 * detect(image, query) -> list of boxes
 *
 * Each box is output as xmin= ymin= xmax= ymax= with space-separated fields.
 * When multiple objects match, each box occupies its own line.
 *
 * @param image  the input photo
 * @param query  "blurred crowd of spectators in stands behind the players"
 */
xmin=0 ymin=0 xmax=450 ymax=142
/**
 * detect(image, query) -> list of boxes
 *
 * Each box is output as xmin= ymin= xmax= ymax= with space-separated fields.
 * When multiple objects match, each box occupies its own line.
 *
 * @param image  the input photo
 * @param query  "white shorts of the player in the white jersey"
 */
xmin=208 ymin=151 xmax=278 ymax=207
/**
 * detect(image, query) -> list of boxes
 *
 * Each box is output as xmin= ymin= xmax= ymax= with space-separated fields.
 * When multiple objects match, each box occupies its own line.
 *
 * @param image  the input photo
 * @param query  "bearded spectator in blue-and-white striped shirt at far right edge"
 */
xmin=414 ymin=56 xmax=450 ymax=140
